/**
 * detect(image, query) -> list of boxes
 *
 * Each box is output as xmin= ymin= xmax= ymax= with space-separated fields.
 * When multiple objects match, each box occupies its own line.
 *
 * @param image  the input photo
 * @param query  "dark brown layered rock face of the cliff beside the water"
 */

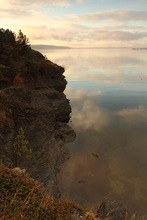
xmin=0 ymin=47 xmax=75 ymax=197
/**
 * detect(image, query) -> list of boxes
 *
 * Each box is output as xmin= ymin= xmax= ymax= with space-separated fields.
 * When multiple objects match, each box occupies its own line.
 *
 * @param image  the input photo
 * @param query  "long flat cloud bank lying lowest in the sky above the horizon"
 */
xmin=23 ymin=25 xmax=147 ymax=43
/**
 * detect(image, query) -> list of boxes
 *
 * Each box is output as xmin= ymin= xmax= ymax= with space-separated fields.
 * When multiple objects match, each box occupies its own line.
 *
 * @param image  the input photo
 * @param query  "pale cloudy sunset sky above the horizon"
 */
xmin=0 ymin=0 xmax=147 ymax=48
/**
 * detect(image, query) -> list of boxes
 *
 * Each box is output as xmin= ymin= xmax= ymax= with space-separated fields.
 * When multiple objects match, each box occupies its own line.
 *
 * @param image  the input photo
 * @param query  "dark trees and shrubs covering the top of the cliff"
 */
xmin=0 ymin=28 xmax=58 ymax=84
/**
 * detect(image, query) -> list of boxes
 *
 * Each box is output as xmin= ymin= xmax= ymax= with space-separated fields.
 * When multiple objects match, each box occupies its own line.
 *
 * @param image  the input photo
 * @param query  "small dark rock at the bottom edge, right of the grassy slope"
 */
xmin=96 ymin=198 xmax=128 ymax=220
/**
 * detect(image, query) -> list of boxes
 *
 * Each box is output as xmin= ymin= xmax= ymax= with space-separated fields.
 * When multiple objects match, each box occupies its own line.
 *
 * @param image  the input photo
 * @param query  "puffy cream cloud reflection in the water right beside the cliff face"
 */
xmin=63 ymin=87 xmax=111 ymax=132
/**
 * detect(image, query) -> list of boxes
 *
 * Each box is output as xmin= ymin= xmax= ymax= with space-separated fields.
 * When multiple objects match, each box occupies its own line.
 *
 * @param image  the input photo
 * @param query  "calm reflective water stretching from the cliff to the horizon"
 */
xmin=43 ymin=49 xmax=147 ymax=214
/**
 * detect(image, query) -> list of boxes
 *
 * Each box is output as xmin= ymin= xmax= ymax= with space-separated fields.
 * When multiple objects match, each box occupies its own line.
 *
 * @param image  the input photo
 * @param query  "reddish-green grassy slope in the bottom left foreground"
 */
xmin=0 ymin=164 xmax=94 ymax=220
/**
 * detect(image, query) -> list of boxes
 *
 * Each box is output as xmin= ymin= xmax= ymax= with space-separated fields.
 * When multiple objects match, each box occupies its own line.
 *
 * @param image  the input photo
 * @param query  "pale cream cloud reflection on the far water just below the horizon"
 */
xmin=44 ymin=49 xmax=147 ymax=87
